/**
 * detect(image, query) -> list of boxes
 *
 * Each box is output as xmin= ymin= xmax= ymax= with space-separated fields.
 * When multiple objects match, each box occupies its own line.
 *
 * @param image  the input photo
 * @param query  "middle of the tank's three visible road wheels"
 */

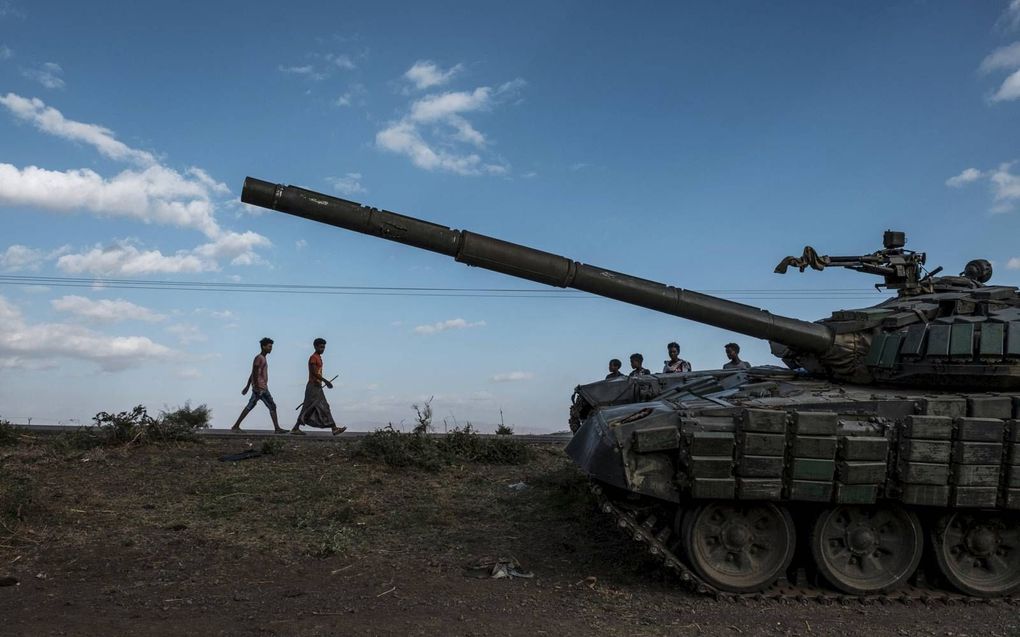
xmin=811 ymin=507 xmax=924 ymax=595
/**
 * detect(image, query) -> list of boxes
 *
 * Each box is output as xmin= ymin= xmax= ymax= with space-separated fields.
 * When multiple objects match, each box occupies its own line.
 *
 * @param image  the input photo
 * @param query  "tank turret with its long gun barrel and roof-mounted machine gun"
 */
xmin=241 ymin=177 xmax=1020 ymax=388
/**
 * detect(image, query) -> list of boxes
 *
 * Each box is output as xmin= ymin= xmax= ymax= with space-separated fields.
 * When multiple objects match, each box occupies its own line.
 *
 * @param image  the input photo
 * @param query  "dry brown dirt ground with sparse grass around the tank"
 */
xmin=0 ymin=436 xmax=1020 ymax=636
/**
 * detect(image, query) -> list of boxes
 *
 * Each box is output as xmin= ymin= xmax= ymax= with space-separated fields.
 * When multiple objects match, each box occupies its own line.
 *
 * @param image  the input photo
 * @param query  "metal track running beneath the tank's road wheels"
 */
xmin=591 ymin=481 xmax=1020 ymax=605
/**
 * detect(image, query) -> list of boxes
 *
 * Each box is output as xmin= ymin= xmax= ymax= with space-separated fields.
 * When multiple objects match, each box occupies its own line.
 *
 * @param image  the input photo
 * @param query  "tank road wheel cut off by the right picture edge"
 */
xmin=931 ymin=512 xmax=1020 ymax=597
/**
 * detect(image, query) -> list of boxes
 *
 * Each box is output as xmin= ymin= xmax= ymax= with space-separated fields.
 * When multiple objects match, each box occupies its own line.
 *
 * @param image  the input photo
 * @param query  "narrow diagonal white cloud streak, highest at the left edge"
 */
xmin=0 ymin=93 xmax=156 ymax=166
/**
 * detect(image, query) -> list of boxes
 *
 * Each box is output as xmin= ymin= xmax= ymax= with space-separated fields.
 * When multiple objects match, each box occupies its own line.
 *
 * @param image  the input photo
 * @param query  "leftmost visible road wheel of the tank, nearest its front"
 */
xmin=683 ymin=501 xmax=797 ymax=593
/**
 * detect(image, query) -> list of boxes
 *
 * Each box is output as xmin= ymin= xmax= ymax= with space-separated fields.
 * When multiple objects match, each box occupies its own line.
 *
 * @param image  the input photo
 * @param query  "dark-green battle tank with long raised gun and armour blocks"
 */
xmin=242 ymin=177 xmax=1020 ymax=601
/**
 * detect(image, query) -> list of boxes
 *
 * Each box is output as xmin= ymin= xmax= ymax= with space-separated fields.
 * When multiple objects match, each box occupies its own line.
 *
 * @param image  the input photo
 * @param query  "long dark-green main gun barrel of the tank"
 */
xmin=241 ymin=177 xmax=833 ymax=353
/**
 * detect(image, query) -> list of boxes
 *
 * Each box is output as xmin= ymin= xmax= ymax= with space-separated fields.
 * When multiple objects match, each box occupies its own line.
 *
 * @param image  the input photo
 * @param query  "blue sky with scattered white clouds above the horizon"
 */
xmin=0 ymin=0 xmax=1020 ymax=431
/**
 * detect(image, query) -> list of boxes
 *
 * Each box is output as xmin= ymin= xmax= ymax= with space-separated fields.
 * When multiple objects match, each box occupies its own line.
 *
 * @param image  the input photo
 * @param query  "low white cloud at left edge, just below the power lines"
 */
xmin=0 ymin=297 xmax=175 ymax=371
